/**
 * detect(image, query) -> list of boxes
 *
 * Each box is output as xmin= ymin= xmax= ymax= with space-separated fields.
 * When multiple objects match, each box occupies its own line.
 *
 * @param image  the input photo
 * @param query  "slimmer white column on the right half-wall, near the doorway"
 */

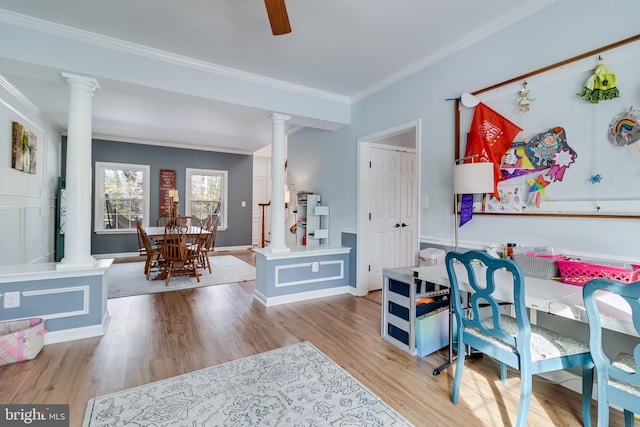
xmin=269 ymin=113 xmax=290 ymax=252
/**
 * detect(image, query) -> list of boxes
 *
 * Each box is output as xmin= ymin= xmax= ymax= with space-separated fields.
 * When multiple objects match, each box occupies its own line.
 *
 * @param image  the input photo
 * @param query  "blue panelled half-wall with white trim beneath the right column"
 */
xmin=254 ymin=247 xmax=353 ymax=306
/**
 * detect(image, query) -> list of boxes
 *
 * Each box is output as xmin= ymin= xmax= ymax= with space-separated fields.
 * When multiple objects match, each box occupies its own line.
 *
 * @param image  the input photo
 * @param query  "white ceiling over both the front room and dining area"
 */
xmin=0 ymin=0 xmax=554 ymax=152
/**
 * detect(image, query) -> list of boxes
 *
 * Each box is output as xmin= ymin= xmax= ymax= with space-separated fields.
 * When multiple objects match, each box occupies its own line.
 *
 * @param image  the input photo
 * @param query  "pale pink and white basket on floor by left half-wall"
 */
xmin=0 ymin=318 xmax=47 ymax=366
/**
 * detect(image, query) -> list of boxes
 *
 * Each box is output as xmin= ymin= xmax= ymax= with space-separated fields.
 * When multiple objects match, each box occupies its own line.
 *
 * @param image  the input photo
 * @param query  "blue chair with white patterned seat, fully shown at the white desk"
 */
xmin=446 ymin=251 xmax=594 ymax=427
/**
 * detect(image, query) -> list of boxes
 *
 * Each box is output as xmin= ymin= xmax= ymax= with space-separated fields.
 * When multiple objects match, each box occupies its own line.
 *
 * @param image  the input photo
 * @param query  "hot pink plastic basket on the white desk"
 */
xmin=556 ymin=259 xmax=640 ymax=286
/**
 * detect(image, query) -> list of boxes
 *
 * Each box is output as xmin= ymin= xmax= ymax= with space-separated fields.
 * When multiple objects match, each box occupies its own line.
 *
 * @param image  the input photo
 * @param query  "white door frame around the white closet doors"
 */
xmin=356 ymin=119 xmax=422 ymax=296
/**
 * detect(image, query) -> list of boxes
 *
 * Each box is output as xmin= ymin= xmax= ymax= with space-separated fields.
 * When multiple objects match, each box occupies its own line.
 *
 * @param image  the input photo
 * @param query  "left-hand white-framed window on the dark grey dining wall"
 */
xmin=94 ymin=162 xmax=149 ymax=233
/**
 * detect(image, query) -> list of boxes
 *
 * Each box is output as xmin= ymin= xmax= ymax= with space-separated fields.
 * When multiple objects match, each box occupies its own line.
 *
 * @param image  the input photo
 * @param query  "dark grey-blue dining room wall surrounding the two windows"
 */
xmin=62 ymin=138 xmax=253 ymax=254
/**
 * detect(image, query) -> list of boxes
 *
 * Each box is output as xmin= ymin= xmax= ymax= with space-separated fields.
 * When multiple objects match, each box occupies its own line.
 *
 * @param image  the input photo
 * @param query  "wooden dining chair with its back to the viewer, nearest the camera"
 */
xmin=162 ymin=216 xmax=200 ymax=286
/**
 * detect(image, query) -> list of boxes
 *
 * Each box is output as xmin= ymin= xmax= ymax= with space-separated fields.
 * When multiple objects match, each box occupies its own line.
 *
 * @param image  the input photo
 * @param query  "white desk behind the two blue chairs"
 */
xmin=413 ymin=264 xmax=637 ymax=375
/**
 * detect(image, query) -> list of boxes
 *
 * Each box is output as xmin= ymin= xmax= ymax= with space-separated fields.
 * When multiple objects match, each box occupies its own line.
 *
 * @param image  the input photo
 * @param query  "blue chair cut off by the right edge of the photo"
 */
xmin=582 ymin=279 xmax=640 ymax=427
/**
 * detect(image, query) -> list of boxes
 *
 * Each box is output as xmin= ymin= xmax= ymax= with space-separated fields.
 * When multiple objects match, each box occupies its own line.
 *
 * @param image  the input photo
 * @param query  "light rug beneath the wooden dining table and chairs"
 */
xmin=106 ymin=255 xmax=256 ymax=298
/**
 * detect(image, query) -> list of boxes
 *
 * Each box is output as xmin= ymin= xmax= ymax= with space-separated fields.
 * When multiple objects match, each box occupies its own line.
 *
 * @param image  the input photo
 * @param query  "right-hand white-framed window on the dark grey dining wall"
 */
xmin=185 ymin=169 xmax=228 ymax=229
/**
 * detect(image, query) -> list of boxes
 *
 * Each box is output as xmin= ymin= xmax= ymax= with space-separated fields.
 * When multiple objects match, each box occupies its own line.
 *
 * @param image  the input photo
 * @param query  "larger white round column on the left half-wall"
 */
xmin=59 ymin=73 xmax=99 ymax=268
